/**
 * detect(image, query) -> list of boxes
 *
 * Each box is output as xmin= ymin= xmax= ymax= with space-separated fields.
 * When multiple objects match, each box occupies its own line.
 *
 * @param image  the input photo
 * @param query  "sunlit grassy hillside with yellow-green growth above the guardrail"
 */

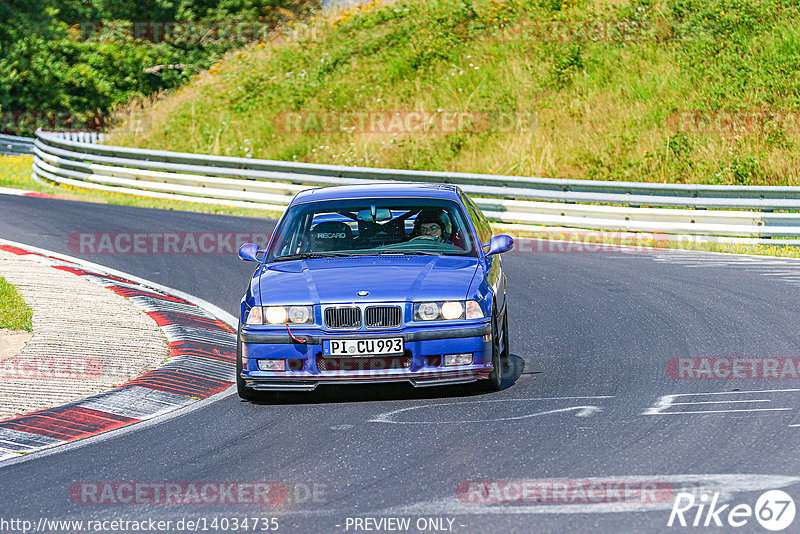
xmin=113 ymin=0 xmax=800 ymax=185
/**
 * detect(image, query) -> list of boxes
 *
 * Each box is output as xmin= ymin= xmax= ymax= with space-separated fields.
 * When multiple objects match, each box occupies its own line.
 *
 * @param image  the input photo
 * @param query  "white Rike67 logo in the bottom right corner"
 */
xmin=667 ymin=490 xmax=795 ymax=532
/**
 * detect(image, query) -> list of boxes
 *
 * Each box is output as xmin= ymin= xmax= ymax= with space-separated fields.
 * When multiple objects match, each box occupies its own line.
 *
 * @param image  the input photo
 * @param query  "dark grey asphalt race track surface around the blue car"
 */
xmin=0 ymin=195 xmax=800 ymax=533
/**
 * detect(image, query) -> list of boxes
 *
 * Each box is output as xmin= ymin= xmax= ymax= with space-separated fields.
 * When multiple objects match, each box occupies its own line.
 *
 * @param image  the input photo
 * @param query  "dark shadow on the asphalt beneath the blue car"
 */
xmin=242 ymin=354 xmax=525 ymax=405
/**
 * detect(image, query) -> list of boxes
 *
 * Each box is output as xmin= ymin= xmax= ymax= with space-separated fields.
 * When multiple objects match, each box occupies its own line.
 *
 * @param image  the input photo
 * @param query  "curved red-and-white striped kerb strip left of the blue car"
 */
xmin=0 ymin=239 xmax=237 ymax=465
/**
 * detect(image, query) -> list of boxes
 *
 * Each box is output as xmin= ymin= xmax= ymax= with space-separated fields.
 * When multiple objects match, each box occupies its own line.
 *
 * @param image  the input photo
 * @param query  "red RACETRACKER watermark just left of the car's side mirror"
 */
xmin=67 ymin=232 xmax=270 ymax=254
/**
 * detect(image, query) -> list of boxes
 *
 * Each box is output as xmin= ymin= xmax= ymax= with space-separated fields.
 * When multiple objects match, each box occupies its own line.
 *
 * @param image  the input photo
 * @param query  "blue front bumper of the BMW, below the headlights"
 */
xmin=241 ymin=322 xmax=492 ymax=391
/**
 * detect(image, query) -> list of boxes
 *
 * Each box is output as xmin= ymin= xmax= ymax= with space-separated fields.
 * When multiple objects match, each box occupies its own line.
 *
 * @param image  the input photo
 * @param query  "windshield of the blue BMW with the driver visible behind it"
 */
xmin=267 ymin=198 xmax=477 ymax=263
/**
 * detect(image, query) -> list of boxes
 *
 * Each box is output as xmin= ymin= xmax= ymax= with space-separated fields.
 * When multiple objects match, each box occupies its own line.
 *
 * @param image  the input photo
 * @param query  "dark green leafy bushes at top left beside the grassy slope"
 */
xmin=0 ymin=0 xmax=319 ymax=134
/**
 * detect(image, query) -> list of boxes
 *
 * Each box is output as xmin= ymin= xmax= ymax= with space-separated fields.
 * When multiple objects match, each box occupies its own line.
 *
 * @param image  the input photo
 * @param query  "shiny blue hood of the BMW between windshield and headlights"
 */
xmin=259 ymin=256 xmax=478 ymax=305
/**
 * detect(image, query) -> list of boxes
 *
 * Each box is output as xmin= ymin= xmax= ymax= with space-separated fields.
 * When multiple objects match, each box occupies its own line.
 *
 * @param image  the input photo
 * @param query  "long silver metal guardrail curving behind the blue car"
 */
xmin=34 ymin=132 xmax=800 ymax=243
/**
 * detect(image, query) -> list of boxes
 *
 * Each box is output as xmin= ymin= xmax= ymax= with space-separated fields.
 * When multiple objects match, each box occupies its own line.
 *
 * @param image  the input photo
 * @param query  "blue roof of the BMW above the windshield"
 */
xmin=292 ymin=182 xmax=461 ymax=204
